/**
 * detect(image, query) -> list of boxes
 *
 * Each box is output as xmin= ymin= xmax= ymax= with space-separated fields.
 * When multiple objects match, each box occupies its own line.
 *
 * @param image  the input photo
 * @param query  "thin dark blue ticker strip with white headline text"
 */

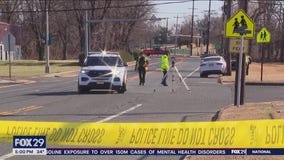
xmin=43 ymin=148 xmax=284 ymax=155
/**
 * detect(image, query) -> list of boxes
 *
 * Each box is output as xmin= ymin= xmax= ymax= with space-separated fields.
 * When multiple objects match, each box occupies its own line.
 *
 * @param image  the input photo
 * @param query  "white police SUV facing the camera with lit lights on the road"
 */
xmin=78 ymin=52 xmax=127 ymax=93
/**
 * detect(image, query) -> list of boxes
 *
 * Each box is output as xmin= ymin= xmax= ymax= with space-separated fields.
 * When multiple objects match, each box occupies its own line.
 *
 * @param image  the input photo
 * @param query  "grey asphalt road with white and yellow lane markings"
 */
xmin=0 ymin=57 xmax=284 ymax=160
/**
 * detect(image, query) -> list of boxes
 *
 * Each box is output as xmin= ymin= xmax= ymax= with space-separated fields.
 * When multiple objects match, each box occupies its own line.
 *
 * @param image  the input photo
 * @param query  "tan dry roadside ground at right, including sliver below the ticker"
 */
xmin=185 ymin=63 xmax=284 ymax=160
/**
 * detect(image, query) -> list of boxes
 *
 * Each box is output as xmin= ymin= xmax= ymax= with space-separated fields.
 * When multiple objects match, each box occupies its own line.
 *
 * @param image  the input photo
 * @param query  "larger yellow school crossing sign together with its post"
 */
xmin=225 ymin=9 xmax=254 ymax=107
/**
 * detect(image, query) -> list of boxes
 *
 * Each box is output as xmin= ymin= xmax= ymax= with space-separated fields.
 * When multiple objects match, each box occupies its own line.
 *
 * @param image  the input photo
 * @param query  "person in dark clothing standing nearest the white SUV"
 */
xmin=137 ymin=52 xmax=149 ymax=86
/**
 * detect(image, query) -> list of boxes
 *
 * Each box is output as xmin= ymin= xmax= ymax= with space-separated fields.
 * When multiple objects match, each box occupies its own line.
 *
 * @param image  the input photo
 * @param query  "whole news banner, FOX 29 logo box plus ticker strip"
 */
xmin=13 ymin=136 xmax=284 ymax=155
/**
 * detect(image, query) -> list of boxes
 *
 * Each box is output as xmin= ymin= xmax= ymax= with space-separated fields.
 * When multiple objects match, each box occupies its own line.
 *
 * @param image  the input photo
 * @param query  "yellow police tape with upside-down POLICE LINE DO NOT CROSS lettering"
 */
xmin=0 ymin=120 xmax=284 ymax=148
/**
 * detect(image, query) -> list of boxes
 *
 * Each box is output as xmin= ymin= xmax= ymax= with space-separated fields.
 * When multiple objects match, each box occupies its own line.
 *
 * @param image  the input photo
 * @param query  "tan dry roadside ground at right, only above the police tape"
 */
xmin=218 ymin=63 xmax=284 ymax=120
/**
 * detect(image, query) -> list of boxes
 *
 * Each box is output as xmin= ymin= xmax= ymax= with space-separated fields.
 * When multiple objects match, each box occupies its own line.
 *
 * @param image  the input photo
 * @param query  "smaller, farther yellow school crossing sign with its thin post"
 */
xmin=256 ymin=27 xmax=270 ymax=82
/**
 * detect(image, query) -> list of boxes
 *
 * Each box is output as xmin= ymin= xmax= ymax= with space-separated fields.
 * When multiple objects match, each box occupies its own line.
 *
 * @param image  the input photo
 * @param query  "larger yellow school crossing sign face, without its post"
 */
xmin=225 ymin=9 xmax=254 ymax=38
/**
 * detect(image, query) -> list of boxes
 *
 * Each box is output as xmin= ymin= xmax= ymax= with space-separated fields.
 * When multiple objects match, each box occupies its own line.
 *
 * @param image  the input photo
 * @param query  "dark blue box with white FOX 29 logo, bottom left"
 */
xmin=13 ymin=136 xmax=46 ymax=148
